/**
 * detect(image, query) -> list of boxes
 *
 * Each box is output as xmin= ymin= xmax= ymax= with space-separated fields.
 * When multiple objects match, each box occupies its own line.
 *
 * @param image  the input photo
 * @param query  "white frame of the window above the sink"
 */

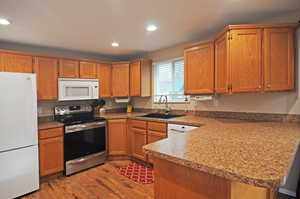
xmin=152 ymin=57 xmax=190 ymax=104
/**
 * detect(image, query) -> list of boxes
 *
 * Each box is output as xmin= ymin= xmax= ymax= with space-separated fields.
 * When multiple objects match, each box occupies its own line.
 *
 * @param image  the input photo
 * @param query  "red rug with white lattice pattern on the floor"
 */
xmin=119 ymin=163 xmax=154 ymax=184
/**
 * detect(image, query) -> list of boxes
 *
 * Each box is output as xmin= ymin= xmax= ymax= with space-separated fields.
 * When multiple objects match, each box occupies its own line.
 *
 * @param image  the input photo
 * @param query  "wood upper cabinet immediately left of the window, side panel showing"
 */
xmin=130 ymin=59 xmax=152 ymax=97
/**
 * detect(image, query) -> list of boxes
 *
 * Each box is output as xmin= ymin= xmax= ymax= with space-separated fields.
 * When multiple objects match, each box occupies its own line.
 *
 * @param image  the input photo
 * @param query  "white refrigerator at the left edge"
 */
xmin=0 ymin=72 xmax=39 ymax=199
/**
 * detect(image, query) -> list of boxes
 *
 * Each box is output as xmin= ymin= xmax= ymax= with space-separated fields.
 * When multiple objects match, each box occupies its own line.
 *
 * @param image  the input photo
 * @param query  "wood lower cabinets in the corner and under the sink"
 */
xmin=107 ymin=119 xmax=167 ymax=163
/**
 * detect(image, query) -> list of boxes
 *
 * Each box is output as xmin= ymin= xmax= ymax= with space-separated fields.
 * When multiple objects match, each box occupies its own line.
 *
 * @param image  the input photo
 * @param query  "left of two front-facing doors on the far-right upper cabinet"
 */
xmin=230 ymin=29 xmax=262 ymax=93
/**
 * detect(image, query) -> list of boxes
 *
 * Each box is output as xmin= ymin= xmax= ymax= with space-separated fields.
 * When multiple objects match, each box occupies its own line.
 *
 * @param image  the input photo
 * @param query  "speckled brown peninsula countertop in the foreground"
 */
xmin=144 ymin=116 xmax=300 ymax=189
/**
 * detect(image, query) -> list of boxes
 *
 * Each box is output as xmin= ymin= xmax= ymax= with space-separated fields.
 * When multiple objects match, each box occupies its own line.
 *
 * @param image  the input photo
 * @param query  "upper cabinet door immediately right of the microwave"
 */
xmin=97 ymin=64 xmax=111 ymax=97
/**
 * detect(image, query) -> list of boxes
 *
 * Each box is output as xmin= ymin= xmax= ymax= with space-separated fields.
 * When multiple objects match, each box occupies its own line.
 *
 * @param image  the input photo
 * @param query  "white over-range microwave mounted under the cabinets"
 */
xmin=58 ymin=78 xmax=99 ymax=101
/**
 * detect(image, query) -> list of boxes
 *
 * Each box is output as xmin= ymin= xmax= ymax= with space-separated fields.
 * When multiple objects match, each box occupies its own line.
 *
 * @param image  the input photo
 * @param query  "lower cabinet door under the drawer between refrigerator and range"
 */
xmin=39 ymin=136 xmax=64 ymax=176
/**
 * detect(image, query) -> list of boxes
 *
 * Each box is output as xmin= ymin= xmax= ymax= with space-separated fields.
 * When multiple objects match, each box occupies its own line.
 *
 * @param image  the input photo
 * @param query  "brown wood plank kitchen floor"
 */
xmin=22 ymin=160 xmax=293 ymax=199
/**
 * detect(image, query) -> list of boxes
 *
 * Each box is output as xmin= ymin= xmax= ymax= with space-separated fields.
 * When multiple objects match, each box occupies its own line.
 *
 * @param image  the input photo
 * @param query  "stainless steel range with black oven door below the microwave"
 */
xmin=54 ymin=104 xmax=107 ymax=176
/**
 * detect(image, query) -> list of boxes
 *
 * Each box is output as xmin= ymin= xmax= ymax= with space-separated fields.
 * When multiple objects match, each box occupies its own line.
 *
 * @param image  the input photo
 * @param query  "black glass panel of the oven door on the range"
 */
xmin=64 ymin=127 xmax=106 ymax=162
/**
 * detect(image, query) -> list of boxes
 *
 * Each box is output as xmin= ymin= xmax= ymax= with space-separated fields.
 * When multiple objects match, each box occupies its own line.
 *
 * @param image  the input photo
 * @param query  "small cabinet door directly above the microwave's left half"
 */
xmin=59 ymin=59 xmax=79 ymax=78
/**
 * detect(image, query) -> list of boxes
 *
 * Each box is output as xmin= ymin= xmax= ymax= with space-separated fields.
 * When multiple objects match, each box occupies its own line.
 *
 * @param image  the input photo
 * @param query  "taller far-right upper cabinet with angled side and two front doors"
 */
xmin=215 ymin=24 xmax=297 ymax=93
